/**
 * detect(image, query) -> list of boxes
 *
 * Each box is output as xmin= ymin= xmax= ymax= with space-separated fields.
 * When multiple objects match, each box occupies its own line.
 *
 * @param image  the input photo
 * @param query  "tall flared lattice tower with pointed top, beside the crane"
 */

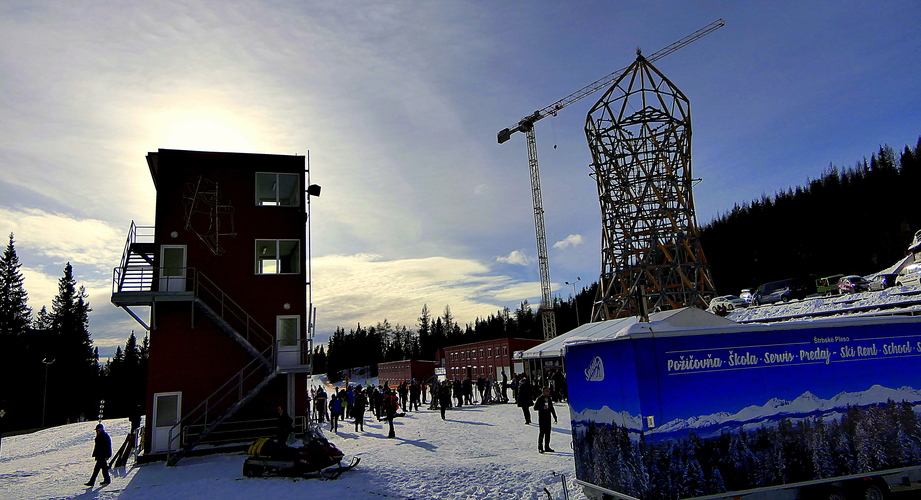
xmin=585 ymin=55 xmax=715 ymax=321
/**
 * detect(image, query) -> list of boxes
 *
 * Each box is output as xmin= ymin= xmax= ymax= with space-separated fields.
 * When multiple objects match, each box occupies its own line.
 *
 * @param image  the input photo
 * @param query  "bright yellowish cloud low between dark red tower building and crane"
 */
xmin=312 ymin=254 xmax=540 ymax=337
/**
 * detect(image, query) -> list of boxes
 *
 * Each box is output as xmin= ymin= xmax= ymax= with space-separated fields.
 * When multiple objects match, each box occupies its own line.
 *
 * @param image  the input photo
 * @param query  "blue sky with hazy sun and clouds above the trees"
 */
xmin=0 ymin=0 xmax=921 ymax=357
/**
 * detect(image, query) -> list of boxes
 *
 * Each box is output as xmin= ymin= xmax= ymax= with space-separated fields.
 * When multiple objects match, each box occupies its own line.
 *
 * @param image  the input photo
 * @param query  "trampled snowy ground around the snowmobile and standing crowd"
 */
xmin=0 ymin=384 xmax=585 ymax=500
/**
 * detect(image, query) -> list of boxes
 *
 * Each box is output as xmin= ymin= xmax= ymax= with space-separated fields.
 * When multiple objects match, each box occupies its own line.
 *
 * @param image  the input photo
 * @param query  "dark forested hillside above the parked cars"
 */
xmin=700 ymin=138 xmax=921 ymax=295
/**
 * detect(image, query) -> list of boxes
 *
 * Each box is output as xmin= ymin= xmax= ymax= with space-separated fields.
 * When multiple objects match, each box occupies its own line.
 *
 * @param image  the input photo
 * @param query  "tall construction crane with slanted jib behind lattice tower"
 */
xmin=497 ymin=19 xmax=726 ymax=340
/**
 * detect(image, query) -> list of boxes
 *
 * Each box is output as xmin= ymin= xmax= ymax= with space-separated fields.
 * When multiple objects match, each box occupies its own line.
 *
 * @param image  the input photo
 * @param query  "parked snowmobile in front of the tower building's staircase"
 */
xmin=243 ymin=425 xmax=360 ymax=479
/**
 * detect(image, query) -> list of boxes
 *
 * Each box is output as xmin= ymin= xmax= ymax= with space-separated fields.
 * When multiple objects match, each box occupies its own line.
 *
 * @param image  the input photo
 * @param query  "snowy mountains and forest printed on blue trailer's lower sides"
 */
xmin=572 ymin=385 xmax=921 ymax=500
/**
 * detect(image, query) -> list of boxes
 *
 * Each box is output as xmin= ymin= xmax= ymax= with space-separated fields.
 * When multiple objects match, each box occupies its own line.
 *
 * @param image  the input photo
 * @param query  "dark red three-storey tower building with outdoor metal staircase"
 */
xmin=112 ymin=149 xmax=319 ymax=463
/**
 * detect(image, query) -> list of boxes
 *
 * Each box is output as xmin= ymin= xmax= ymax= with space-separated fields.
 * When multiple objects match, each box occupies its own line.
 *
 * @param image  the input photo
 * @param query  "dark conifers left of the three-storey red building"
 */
xmin=0 ymin=233 xmax=148 ymax=431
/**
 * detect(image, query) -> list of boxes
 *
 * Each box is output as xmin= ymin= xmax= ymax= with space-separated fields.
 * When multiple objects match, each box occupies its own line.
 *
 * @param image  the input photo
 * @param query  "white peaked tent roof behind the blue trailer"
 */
xmin=521 ymin=307 xmax=736 ymax=359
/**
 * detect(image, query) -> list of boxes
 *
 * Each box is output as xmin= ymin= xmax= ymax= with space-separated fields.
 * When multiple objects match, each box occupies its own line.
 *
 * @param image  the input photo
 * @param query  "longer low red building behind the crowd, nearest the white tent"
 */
xmin=444 ymin=338 xmax=543 ymax=381
